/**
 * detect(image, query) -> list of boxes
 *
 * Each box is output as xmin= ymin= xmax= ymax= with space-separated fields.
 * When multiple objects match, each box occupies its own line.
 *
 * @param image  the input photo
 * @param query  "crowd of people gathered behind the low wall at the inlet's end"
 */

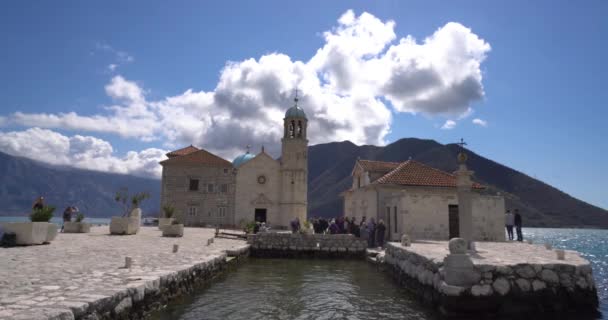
xmin=290 ymin=217 xmax=386 ymax=248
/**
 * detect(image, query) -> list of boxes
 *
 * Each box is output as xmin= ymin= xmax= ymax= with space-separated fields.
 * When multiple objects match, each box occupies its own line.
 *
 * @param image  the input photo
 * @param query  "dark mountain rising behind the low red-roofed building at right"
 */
xmin=308 ymin=138 xmax=608 ymax=228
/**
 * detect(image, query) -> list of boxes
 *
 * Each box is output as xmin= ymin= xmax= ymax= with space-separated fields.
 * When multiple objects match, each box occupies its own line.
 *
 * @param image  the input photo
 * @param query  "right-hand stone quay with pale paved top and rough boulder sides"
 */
xmin=382 ymin=238 xmax=599 ymax=318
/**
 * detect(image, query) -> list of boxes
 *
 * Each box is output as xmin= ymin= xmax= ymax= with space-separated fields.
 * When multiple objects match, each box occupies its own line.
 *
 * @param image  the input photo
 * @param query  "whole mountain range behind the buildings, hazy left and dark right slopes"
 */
xmin=0 ymin=138 xmax=608 ymax=228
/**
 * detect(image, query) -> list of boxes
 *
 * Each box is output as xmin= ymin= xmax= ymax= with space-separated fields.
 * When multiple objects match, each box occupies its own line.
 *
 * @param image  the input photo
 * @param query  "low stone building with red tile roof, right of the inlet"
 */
xmin=342 ymin=154 xmax=505 ymax=241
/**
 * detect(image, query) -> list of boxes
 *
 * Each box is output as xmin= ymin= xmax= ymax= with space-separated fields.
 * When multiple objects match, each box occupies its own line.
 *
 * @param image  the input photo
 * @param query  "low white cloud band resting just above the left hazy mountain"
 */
xmin=0 ymin=128 xmax=167 ymax=178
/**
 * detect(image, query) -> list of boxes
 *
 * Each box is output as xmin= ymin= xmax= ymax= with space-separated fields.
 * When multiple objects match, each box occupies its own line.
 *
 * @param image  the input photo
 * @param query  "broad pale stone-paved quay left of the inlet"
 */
xmin=0 ymin=226 xmax=249 ymax=320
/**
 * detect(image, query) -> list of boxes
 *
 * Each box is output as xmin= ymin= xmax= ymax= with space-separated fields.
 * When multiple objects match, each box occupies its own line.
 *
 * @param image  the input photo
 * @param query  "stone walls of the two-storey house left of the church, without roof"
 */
xmin=161 ymin=161 xmax=236 ymax=226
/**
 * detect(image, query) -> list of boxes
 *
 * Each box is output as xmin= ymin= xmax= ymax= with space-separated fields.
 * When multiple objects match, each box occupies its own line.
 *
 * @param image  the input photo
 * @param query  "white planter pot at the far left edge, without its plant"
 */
xmin=2 ymin=222 xmax=57 ymax=245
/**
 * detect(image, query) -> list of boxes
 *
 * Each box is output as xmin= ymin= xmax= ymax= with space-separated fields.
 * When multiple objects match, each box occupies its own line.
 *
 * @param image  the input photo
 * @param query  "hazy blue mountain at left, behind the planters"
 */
xmin=0 ymin=152 xmax=160 ymax=217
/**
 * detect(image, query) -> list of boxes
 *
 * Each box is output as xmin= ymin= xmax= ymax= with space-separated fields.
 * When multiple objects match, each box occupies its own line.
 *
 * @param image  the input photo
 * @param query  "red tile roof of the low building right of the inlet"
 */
xmin=372 ymin=160 xmax=483 ymax=189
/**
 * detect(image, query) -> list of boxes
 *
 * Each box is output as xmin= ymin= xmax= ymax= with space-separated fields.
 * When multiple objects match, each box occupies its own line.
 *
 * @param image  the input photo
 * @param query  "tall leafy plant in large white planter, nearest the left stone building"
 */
xmin=110 ymin=188 xmax=150 ymax=235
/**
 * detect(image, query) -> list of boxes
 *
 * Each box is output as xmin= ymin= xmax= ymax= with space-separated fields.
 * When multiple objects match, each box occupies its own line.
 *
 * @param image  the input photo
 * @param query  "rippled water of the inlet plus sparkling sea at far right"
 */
xmin=152 ymin=228 xmax=608 ymax=320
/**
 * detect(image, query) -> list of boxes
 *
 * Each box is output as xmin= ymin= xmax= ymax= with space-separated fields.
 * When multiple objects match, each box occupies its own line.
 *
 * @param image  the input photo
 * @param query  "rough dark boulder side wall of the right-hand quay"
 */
xmin=384 ymin=243 xmax=598 ymax=317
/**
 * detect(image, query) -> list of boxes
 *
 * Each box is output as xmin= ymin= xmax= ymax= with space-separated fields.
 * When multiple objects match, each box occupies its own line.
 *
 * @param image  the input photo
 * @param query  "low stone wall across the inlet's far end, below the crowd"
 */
xmin=247 ymin=232 xmax=367 ymax=258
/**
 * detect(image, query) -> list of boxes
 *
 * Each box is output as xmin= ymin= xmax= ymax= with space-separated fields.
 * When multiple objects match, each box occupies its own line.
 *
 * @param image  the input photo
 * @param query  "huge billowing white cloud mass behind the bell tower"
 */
xmin=5 ymin=10 xmax=490 ymax=166
